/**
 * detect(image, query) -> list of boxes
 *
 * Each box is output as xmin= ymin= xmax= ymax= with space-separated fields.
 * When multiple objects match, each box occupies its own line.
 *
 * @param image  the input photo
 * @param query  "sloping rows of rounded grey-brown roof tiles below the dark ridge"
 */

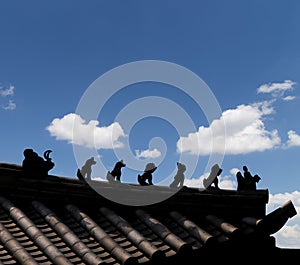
xmin=0 ymin=192 xmax=296 ymax=265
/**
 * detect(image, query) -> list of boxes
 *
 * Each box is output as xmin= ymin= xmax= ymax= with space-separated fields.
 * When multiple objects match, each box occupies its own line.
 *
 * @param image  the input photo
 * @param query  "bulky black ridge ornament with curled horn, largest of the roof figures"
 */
xmin=22 ymin=148 xmax=55 ymax=178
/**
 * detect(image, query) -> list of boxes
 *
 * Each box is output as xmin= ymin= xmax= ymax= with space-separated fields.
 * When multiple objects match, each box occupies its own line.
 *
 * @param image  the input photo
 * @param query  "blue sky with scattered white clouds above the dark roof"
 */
xmin=0 ymin=0 xmax=300 ymax=248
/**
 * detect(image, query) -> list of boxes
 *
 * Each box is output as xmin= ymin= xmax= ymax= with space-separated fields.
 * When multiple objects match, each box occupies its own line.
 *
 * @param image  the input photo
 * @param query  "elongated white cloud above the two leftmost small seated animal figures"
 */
xmin=46 ymin=113 xmax=126 ymax=149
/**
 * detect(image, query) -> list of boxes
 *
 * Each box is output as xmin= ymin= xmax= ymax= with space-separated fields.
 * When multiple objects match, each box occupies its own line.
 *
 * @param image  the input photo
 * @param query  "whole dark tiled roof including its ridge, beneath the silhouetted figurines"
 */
xmin=0 ymin=163 xmax=296 ymax=265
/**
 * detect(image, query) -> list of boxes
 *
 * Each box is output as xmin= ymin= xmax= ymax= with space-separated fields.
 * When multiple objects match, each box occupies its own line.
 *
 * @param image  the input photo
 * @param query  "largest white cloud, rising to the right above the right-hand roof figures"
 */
xmin=177 ymin=101 xmax=281 ymax=155
